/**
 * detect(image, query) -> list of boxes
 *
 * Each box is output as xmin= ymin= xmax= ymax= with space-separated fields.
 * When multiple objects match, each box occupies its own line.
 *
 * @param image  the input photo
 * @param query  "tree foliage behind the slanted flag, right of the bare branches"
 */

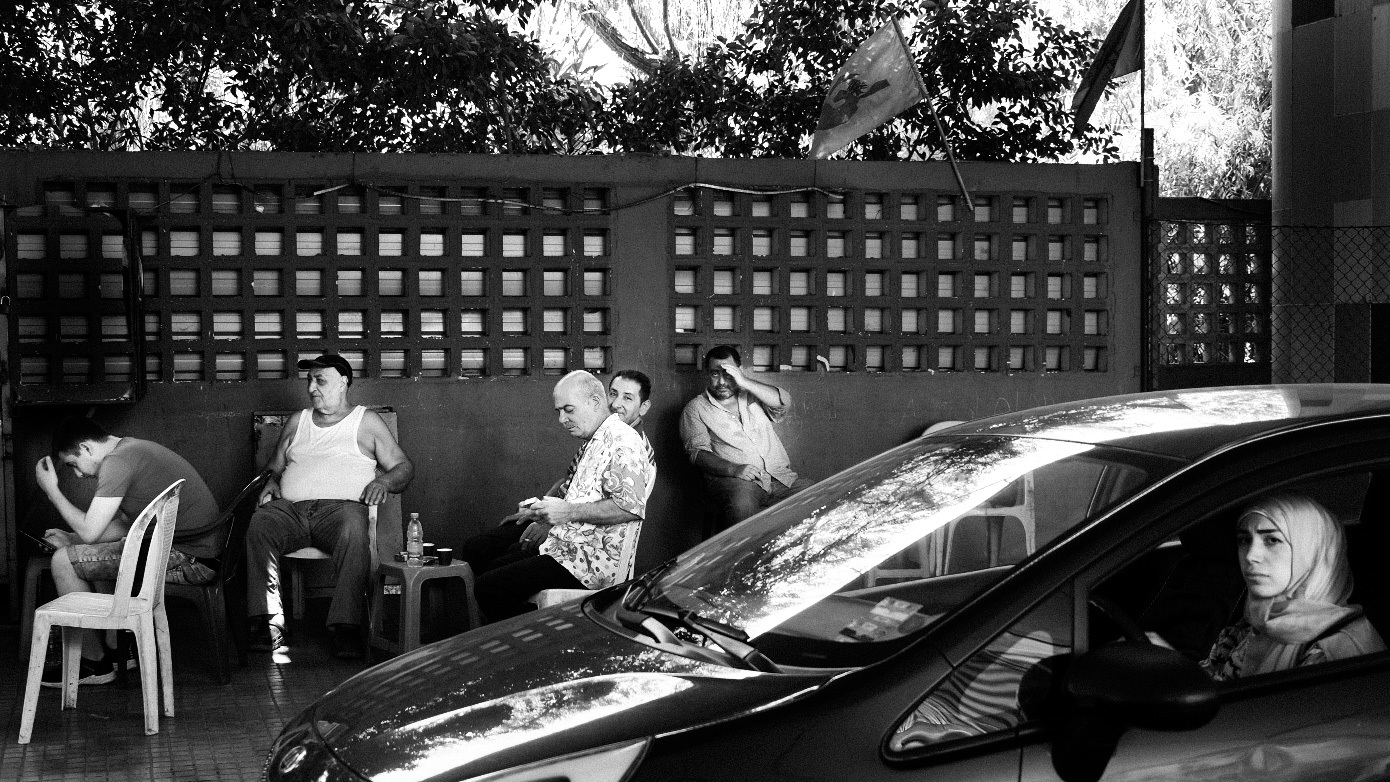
xmin=606 ymin=0 xmax=1115 ymax=161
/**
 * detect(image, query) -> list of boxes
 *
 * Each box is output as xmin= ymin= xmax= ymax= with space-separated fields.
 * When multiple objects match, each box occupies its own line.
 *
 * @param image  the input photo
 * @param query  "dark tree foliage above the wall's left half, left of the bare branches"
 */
xmin=0 ymin=0 xmax=602 ymax=153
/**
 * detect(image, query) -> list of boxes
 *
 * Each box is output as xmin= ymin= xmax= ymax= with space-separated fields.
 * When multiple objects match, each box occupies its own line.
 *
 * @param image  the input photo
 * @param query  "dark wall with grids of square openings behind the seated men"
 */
xmin=0 ymin=153 xmax=1141 ymax=565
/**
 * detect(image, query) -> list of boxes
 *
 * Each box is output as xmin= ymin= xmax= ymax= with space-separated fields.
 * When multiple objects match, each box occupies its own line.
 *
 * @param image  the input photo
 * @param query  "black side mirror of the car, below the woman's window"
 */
xmin=1052 ymin=642 xmax=1219 ymax=782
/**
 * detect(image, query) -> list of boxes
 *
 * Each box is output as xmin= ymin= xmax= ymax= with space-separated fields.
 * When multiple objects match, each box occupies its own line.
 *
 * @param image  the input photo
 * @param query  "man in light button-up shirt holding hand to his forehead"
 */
xmin=681 ymin=344 xmax=812 ymax=529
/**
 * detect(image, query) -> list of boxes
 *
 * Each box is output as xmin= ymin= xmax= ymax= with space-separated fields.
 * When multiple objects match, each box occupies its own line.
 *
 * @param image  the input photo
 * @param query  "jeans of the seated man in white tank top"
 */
xmin=246 ymin=499 xmax=371 ymax=626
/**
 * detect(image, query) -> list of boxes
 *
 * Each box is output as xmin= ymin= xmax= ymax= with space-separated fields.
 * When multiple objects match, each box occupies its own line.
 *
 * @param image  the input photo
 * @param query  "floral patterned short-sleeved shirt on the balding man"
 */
xmin=541 ymin=415 xmax=656 ymax=589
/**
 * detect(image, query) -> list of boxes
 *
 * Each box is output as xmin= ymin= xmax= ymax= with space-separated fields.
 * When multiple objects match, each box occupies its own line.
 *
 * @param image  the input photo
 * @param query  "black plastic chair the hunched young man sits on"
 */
xmin=164 ymin=469 xmax=270 ymax=685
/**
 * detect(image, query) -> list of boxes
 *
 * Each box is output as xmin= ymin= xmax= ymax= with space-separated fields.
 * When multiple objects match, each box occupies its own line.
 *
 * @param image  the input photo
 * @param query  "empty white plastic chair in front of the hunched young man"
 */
xmin=19 ymin=479 xmax=183 ymax=744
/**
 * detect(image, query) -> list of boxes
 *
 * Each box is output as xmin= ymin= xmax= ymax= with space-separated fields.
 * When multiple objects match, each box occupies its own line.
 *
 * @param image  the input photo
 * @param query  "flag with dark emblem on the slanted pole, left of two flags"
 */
xmin=810 ymin=19 xmax=927 ymax=158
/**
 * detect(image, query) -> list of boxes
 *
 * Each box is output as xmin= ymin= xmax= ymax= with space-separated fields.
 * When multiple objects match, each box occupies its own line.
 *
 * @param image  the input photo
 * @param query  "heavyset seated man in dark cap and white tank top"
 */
xmin=246 ymin=354 xmax=414 ymax=658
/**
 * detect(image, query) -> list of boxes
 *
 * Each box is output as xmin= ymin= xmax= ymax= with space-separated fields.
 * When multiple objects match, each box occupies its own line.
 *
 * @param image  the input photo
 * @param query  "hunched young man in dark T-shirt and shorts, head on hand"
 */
xmin=33 ymin=417 xmax=221 ymax=688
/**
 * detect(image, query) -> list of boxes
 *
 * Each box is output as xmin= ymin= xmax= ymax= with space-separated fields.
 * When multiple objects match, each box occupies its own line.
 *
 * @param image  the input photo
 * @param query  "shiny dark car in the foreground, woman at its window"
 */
xmin=265 ymin=383 xmax=1390 ymax=782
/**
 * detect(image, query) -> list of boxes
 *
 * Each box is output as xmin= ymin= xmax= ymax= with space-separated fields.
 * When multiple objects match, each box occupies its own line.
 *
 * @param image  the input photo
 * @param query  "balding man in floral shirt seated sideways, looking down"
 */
xmin=461 ymin=371 xmax=656 ymax=621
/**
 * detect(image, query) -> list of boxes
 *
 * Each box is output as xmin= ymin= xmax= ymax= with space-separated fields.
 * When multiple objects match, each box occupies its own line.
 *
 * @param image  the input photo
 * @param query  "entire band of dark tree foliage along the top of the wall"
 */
xmin=0 ymin=0 xmax=1113 ymax=161
